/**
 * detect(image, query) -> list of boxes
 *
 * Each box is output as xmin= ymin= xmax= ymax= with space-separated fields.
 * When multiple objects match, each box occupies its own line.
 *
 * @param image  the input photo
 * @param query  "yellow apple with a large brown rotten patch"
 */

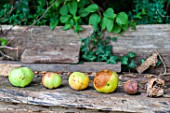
xmin=93 ymin=70 xmax=119 ymax=93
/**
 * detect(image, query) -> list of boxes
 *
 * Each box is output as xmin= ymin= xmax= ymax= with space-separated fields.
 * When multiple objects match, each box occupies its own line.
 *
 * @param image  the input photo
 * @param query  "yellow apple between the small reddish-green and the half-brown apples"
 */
xmin=68 ymin=72 xmax=90 ymax=91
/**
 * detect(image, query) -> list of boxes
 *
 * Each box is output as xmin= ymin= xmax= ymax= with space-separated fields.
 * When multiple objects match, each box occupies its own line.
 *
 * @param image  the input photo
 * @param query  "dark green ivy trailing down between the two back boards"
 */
xmin=81 ymin=32 xmax=137 ymax=71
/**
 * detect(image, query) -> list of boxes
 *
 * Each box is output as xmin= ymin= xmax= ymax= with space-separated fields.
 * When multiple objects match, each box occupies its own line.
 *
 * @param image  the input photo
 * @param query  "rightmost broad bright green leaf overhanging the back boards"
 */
xmin=116 ymin=12 xmax=128 ymax=26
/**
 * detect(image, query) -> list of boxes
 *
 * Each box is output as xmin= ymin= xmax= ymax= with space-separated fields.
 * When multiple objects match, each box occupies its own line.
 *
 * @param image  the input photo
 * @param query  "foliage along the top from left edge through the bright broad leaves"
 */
xmin=0 ymin=0 xmax=128 ymax=33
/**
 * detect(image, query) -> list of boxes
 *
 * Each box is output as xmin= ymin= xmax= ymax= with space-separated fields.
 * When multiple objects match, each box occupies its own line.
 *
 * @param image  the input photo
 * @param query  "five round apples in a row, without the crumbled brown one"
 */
xmin=8 ymin=67 xmax=138 ymax=94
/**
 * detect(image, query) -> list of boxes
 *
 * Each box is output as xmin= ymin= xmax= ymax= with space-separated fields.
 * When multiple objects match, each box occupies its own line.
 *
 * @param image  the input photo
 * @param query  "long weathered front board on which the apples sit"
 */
xmin=0 ymin=76 xmax=170 ymax=113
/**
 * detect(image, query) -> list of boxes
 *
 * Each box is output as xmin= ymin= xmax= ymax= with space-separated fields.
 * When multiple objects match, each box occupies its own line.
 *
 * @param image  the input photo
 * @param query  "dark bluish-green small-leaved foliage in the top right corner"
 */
xmin=129 ymin=0 xmax=169 ymax=24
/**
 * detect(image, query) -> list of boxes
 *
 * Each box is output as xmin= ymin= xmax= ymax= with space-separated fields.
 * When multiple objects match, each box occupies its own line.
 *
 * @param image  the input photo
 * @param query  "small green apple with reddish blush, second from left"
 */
xmin=42 ymin=72 xmax=62 ymax=89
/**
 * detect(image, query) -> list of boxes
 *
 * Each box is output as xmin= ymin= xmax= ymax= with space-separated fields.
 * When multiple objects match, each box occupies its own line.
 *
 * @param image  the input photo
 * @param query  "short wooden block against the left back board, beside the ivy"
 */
xmin=21 ymin=45 xmax=79 ymax=63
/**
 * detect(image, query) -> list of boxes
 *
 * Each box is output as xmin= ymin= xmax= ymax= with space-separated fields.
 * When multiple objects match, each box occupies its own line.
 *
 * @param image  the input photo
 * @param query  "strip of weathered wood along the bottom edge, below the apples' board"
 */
xmin=0 ymin=102 xmax=125 ymax=113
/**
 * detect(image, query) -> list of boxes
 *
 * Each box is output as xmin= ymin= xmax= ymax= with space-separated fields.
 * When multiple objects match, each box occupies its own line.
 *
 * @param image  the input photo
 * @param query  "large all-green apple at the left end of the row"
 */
xmin=8 ymin=67 xmax=34 ymax=88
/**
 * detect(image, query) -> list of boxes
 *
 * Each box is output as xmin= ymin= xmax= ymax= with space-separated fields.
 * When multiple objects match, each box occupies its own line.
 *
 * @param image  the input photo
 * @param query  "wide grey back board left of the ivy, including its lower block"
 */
xmin=1 ymin=25 xmax=93 ymax=63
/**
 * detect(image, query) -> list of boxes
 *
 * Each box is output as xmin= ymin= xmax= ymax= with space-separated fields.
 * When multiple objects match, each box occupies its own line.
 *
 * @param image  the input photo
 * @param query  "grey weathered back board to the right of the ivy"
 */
xmin=105 ymin=24 xmax=170 ymax=73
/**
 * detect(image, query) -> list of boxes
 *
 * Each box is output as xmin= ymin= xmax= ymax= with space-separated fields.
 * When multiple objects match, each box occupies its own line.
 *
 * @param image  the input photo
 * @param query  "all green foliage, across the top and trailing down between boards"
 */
xmin=0 ymin=0 xmax=167 ymax=71
